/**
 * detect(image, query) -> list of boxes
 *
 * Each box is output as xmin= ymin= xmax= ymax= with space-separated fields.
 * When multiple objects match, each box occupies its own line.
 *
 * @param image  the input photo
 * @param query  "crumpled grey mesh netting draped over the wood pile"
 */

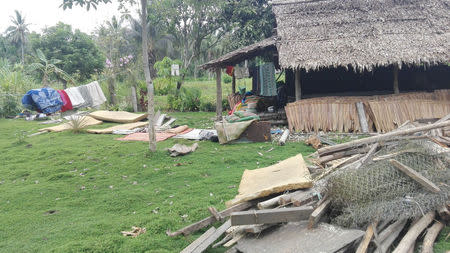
xmin=327 ymin=140 xmax=450 ymax=227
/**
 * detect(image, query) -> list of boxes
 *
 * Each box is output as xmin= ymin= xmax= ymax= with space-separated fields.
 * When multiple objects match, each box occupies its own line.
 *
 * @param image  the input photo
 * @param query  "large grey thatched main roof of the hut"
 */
xmin=272 ymin=0 xmax=450 ymax=71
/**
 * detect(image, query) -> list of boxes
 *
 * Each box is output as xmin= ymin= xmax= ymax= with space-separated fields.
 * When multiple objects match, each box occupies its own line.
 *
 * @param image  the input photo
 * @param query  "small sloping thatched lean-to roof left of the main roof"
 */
xmin=200 ymin=36 xmax=276 ymax=69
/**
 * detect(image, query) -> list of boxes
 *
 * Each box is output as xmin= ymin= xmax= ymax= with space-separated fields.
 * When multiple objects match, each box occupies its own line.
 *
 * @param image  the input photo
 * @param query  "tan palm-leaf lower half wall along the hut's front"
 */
xmin=285 ymin=89 xmax=450 ymax=132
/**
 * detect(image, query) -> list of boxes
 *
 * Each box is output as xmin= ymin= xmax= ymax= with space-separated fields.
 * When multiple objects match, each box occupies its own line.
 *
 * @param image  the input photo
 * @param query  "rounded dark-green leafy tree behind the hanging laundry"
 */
xmin=32 ymin=22 xmax=105 ymax=81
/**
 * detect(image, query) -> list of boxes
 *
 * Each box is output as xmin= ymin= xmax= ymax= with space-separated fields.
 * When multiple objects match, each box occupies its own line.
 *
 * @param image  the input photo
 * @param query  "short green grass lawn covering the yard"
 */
xmin=0 ymin=113 xmax=313 ymax=252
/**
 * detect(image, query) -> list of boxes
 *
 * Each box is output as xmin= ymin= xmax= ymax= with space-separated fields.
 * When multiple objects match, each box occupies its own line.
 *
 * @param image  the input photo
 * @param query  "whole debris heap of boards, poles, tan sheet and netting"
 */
xmin=172 ymin=115 xmax=450 ymax=253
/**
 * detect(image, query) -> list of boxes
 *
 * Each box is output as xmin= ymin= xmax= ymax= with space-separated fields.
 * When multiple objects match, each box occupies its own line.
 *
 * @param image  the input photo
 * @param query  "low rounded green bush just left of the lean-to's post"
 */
xmin=167 ymin=87 xmax=202 ymax=112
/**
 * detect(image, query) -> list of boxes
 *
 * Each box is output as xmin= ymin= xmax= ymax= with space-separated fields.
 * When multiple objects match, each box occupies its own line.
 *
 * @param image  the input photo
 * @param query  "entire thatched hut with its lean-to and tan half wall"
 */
xmin=202 ymin=0 xmax=450 ymax=132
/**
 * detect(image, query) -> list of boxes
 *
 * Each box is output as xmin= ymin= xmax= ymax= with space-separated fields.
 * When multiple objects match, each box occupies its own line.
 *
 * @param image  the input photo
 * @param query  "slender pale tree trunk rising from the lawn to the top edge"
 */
xmin=141 ymin=0 xmax=156 ymax=152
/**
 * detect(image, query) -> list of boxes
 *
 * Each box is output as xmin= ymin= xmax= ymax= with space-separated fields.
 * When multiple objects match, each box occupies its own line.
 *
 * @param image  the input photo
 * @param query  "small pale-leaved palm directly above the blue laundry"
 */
xmin=30 ymin=49 xmax=73 ymax=86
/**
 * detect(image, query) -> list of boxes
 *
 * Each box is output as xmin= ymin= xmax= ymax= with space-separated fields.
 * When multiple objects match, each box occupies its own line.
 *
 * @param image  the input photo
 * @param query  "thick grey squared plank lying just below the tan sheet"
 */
xmin=231 ymin=206 xmax=313 ymax=226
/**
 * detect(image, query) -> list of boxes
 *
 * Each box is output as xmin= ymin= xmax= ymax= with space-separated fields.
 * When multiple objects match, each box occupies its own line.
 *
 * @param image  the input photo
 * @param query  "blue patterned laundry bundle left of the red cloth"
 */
xmin=22 ymin=88 xmax=63 ymax=114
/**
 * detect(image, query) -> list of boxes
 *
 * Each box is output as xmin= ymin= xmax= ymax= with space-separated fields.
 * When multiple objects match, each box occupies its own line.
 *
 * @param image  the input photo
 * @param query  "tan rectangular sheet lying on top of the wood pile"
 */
xmin=226 ymin=154 xmax=313 ymax=207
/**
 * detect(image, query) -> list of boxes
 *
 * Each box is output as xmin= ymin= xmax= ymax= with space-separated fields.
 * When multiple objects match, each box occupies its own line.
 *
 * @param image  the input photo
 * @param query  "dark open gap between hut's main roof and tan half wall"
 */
xmin=286 ymin=65 xmax=450 ymax=98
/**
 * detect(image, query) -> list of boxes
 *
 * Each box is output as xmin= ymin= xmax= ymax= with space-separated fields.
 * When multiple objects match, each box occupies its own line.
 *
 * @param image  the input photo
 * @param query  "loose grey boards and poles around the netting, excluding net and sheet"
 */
xmin=171 ymin=115 xmax=450 ymax=253
